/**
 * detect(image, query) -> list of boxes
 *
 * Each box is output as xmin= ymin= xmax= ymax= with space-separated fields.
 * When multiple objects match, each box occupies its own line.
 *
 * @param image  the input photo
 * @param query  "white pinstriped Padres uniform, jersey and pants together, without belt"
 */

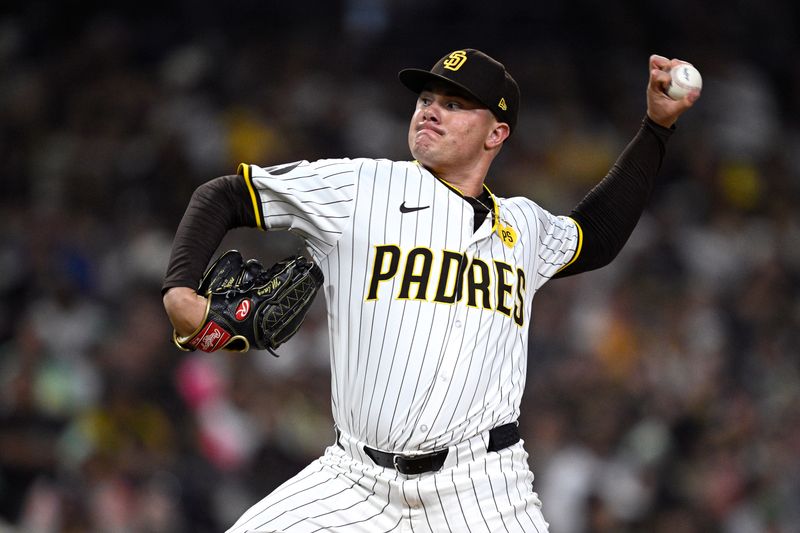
xmin=234 ymin=159 xmax=579 ymax=532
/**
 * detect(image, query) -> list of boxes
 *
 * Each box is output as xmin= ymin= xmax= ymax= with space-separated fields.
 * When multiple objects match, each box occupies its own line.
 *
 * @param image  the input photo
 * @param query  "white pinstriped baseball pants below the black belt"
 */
xmin=229 ymin=436 xmax=547 ymax=533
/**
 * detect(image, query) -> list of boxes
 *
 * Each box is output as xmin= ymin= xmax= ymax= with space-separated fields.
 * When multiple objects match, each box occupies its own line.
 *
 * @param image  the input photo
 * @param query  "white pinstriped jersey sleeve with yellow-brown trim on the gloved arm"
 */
xmin=238 ymin=159 xmax=357 ymax=257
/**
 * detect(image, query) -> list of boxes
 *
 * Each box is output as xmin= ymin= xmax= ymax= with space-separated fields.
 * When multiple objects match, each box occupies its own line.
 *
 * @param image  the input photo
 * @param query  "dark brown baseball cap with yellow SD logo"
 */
xmin=398 ymin=48 xmax=519 ymax=131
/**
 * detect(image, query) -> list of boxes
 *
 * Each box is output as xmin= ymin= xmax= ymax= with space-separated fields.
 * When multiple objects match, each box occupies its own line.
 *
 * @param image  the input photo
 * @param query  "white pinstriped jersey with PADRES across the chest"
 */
xmin=240 ymin=159 xmax=580 ymax=452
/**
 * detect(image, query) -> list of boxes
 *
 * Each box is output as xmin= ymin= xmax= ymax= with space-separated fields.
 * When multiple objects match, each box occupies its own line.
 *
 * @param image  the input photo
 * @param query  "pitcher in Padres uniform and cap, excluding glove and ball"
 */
xmin=164 ymin=49 xmax=699 ymax=533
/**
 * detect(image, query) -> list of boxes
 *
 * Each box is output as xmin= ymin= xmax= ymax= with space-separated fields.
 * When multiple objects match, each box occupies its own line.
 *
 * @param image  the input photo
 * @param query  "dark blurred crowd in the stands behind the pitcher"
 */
xmin=0 ymin=0 xmax=800 ymax=533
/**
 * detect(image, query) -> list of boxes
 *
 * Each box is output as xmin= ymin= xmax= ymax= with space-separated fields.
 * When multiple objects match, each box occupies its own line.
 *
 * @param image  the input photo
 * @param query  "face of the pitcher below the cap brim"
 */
xmin=408 ymin=85 xmax=504 ymax=172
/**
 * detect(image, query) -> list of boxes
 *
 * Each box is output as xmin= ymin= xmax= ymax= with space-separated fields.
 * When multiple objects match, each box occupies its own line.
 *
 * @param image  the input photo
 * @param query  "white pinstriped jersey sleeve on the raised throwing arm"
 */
xmin=533 ymin=204 xmax=583 ymax=289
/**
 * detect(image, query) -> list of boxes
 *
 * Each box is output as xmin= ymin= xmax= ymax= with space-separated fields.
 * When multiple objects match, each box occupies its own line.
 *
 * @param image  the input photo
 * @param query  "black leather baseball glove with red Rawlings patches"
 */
xmin=172 ymin=250 xmax=323 ymax=357
